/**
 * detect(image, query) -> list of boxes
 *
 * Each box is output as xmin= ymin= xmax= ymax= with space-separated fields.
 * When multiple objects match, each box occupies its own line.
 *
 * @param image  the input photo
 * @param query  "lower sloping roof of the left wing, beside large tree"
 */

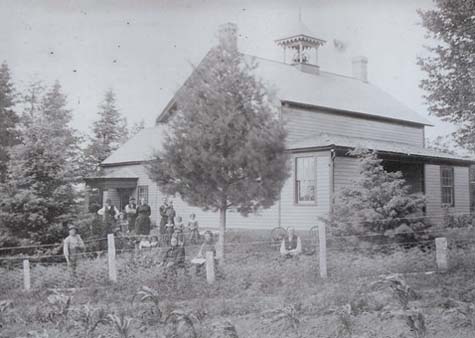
xmin=102 ymin=124 xmax=167 ymax=166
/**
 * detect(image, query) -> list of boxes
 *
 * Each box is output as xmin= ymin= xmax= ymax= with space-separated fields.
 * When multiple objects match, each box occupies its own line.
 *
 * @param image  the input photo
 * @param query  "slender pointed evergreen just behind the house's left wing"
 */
xmin=85 ymin=90 xmax=128 ymax=173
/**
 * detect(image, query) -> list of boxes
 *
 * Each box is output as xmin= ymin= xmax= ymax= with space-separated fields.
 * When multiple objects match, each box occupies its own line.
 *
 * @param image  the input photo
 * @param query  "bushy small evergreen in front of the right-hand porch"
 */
xmin=328 ymin=149 xmax=424 ymax=234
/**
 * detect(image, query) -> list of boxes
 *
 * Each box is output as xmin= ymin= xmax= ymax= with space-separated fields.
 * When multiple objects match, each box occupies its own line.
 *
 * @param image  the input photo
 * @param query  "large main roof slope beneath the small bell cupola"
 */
xmin=157 ymin=55 xmax=431 ymax=126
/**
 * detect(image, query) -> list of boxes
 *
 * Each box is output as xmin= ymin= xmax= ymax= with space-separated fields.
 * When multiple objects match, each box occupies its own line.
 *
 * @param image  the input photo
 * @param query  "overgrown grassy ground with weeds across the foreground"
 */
xmin=0 ymin=231 xmax=475 ymax=338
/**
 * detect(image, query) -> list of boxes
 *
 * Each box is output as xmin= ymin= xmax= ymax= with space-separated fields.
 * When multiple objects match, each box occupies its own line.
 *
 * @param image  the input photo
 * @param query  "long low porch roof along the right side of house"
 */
xmin=288 ymin=133 xmax=475 ymax=163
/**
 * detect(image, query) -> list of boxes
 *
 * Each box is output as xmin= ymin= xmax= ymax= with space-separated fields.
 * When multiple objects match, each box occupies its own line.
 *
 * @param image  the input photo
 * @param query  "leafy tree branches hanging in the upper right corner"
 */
xmin=418 ymin=0 xmax=475 ymax=151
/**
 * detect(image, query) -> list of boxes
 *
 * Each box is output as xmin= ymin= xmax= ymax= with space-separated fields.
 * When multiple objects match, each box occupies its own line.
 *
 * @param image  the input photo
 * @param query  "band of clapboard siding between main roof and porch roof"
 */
xmin=282 ymin=107 xmax=424 ymax=147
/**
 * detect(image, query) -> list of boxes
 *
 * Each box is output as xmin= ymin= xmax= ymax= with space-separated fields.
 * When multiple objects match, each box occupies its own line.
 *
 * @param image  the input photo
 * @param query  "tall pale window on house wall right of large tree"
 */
xmin=295 ymin=157 xmax=317 ymax=204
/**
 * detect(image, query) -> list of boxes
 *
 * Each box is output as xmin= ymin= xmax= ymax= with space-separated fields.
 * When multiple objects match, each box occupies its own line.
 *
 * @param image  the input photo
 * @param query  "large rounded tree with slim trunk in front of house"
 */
xmin=150 ymin=31 xmax=289 ymax=258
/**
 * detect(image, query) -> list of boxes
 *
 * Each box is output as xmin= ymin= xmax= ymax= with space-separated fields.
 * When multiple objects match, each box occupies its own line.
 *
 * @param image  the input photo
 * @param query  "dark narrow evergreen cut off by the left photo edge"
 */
xmin=0 ymin=62 xmax=19 ymax=183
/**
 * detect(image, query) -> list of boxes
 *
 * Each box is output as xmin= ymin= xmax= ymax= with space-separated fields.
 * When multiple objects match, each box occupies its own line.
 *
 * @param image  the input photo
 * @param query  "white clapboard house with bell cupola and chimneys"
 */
xmin=86 ymin=23 xmax=475 ymax=228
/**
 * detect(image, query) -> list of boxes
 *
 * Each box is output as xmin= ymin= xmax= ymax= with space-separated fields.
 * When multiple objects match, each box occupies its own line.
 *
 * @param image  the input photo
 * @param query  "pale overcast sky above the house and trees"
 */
xmin=0 ymin=0 xmax=449 ymax=136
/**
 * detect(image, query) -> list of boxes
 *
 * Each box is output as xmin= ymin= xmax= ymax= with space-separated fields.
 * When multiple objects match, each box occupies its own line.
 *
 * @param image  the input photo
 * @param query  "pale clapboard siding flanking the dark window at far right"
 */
xmin=424 ymin=164 xmax=470 ymax=225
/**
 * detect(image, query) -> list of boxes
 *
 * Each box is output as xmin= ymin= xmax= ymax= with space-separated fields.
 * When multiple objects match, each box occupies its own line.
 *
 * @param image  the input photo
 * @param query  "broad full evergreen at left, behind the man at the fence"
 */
xmin=0 ymin=82 xmax=79 ymax=246
